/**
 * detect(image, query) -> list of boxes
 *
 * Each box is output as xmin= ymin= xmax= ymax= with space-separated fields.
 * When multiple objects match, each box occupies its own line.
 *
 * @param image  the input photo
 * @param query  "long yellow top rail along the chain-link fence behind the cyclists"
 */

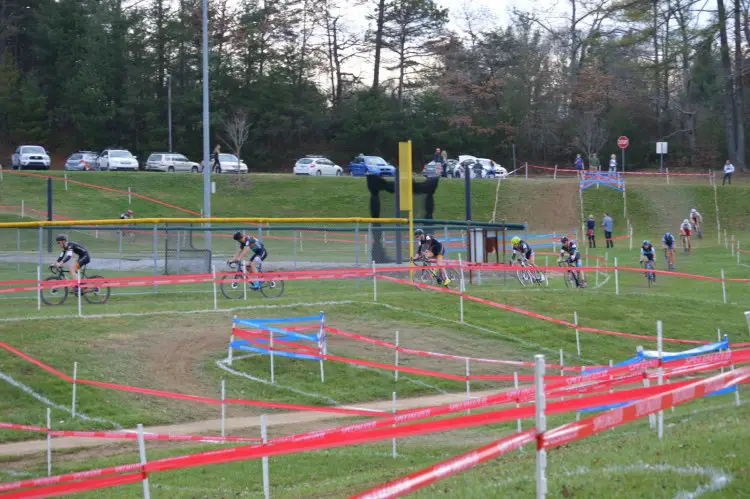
xmin=0 ymin=217 xmax=409 ymax=229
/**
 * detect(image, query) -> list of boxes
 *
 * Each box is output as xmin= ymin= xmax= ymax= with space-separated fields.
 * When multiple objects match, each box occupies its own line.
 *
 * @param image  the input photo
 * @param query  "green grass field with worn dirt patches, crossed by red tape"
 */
xmin=0 ymin=173 xmax=750 ymax=498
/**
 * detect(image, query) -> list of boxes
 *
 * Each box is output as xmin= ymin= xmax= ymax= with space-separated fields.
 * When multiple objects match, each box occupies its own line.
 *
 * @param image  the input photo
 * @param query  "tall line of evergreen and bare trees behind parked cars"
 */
xmin=0 ymin=0 xmax=750 ymax=170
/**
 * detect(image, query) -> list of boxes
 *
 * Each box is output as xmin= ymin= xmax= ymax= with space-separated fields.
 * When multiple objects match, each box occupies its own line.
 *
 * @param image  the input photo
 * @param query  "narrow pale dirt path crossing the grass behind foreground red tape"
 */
xmin=0 ymin=390 xmax=506 ymax=456
